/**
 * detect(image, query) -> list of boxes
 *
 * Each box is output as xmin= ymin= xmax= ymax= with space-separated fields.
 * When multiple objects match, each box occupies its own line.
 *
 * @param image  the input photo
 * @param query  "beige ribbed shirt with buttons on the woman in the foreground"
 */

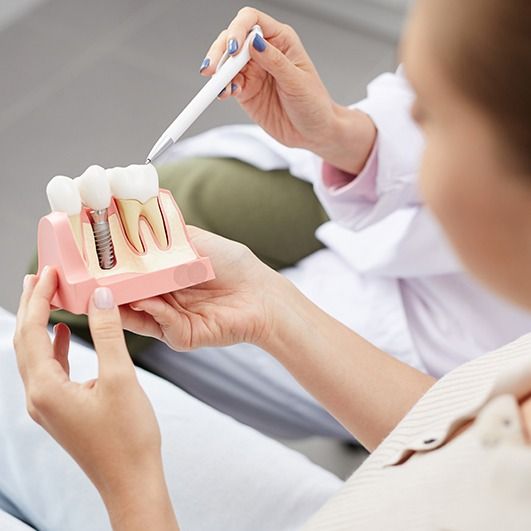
xmin=304 ymin=334 xmax=531 ymax=531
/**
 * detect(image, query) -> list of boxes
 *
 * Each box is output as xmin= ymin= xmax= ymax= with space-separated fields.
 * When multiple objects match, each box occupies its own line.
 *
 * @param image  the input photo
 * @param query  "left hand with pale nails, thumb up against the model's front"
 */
xmin=14 ymin=269 xmax=177 ymax=531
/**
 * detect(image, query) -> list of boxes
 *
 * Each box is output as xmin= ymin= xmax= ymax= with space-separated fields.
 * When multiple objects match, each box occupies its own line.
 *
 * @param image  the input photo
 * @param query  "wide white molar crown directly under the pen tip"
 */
xmin=107 ymin=164 xmax=159 ymax=203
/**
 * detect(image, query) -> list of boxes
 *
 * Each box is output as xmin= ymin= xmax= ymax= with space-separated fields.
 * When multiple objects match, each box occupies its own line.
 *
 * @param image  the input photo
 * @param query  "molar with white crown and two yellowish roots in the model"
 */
xmin=107 ymin=164 xmax=169 ymax=253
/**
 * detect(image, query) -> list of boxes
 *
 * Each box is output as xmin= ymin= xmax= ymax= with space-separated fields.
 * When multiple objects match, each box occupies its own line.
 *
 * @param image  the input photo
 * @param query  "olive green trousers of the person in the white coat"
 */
xmin=32 ymin=158 xmax=328 ymax=355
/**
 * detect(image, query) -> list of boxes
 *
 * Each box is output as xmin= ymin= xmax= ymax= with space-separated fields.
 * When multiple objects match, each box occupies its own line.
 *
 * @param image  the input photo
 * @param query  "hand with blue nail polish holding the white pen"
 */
xmin=201 ymin=7 xmax=376 ymax=174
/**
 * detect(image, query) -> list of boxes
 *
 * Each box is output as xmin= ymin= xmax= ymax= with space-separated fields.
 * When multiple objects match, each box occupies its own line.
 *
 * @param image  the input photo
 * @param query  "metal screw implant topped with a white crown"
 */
xmin=76 ymin=166 xmax=116 ymax=269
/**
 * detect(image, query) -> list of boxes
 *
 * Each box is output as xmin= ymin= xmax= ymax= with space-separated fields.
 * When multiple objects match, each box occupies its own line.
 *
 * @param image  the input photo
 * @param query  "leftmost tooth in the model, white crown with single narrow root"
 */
xmin=46 ymin=175 xmax=83 ymax=255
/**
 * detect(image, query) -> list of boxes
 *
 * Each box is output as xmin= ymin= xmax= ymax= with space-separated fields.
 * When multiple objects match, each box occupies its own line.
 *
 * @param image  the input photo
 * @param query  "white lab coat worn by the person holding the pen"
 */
xmin=161 ymin=68 xmax=531 ymax=377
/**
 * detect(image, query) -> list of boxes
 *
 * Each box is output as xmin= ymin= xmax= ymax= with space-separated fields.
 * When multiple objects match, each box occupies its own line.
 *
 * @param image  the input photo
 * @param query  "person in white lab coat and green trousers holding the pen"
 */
xmin=31 ymin=7 xmax=531 ymax=439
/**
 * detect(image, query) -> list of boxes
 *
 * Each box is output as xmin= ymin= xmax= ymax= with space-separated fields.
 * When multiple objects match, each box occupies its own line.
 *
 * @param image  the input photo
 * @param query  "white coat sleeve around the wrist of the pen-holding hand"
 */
xmin=315 ymin=68 xmax=424 ymax=230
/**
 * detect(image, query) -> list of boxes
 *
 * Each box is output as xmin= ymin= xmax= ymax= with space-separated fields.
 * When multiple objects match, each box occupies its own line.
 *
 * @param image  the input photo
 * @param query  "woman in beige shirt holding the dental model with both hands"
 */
xmin=6 ymin=0 xmax=531 ymax=531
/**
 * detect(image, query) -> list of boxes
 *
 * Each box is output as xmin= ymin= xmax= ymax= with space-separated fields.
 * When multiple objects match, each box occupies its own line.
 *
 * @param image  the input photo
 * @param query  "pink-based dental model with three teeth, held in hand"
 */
xmin=38 ymin=160 xmax=214 ymax=314
